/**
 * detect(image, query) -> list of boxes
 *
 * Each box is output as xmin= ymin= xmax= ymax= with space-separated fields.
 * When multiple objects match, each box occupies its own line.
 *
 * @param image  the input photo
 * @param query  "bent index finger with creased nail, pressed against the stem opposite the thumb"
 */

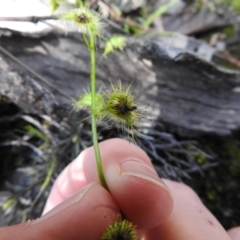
xmin=81 ymin=139 xmax=173 ymax=229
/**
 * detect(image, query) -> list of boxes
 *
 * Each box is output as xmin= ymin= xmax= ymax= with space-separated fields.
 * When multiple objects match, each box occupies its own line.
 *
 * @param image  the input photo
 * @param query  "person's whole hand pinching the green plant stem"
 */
xmin=0 ymin=139 xmax=240 ymax=240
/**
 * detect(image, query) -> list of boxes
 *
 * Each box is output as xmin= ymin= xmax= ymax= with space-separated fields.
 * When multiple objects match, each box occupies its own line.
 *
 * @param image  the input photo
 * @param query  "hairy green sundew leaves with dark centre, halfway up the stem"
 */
xmin=74 ymin=82 xmax=143 ymax=136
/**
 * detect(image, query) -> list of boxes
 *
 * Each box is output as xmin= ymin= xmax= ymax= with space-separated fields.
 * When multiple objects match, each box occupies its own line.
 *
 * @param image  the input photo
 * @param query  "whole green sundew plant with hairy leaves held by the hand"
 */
xmin=58 ymin=4 xmax=142 ymax=240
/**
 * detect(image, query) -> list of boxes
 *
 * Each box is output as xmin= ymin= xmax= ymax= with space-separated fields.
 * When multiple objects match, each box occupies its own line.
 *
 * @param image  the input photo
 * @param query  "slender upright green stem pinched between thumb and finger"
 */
xmin=89 ymin=29 xmax=108 ymax=189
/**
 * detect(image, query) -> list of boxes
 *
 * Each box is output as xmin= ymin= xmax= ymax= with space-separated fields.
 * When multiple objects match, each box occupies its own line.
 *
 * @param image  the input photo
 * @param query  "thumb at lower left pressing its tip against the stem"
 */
xmin=0 ymin=182 xmax=119 ymax=240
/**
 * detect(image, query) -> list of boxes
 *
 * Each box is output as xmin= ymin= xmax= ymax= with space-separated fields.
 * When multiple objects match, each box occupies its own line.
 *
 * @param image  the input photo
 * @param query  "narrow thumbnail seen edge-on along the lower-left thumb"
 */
xmin=30 ymin=182 xmax=96 ymax=225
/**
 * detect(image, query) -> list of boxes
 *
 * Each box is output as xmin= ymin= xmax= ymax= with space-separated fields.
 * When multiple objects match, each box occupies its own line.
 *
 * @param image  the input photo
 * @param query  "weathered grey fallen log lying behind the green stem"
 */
xmin=0 ymin=31 xmax=240 ymax=136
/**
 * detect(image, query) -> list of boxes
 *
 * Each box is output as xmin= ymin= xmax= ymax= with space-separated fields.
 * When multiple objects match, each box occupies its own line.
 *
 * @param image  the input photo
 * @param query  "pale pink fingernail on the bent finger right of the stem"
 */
xmin=121 ymin=159 xmax=168 ymax=189
